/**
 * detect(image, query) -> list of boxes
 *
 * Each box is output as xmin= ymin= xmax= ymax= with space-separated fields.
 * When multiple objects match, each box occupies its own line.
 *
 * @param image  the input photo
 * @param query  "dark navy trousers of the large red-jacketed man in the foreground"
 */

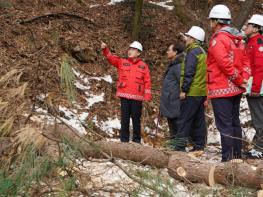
xmin=211 ymin=95 xmax=242 ymax=161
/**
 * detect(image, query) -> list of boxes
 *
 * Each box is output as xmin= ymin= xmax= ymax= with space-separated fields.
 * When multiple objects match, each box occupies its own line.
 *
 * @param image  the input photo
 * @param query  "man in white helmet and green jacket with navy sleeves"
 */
xmin=177 ymin=26 xmax=207 ymax=151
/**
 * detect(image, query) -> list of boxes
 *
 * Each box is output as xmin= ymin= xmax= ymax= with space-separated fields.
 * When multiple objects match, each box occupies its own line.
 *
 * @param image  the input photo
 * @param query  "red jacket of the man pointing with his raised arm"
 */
xmin=103 ymin=48 xmax=152 ymax=101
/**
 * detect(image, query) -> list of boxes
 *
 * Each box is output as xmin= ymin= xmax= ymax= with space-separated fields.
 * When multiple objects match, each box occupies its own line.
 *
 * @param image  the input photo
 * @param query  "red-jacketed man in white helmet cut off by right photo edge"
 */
xmin=244 ymin=14 xmax=263 ymax=158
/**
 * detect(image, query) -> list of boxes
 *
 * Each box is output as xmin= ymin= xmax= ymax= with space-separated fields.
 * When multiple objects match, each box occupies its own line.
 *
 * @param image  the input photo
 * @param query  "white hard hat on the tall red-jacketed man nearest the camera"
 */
xmin=208 ymin=4 xmax=231 ymax=20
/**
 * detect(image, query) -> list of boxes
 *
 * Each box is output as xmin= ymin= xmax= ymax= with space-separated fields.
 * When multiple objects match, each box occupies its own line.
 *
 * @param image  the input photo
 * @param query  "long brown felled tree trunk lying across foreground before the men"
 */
xmin=81 ymin=141 xmax=263 ymax=188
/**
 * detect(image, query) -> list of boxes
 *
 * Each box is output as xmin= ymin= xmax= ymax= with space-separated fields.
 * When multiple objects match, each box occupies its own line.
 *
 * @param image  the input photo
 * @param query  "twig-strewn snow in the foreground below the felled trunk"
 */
xmin=75 ymin=160 xmax=191 ymax=197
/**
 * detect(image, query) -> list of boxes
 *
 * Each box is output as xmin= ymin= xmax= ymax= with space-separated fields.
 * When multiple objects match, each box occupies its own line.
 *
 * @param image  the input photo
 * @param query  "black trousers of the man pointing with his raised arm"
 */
xmin=120 ymin=98 xmax=142 ymax=143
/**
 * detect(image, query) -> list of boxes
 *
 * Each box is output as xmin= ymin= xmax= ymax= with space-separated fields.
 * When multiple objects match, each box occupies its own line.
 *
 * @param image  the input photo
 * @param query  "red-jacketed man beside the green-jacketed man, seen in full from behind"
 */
xmin=207 ymin=5 xmax=250 ymax=162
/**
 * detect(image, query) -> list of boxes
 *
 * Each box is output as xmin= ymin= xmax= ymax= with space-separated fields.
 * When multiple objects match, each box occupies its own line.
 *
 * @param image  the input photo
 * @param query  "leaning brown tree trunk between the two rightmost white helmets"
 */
xmin=234 ymin=0 xmax=256 ymax=30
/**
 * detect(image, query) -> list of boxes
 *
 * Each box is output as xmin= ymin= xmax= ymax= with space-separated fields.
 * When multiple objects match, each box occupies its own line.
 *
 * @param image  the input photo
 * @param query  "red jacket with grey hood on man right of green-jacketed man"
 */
xmin=207 ymin=27 xmax=250 ymax=98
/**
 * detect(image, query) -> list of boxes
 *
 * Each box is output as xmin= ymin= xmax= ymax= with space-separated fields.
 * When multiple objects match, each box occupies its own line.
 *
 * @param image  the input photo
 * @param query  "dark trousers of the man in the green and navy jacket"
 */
xmin=177 ymin=96 xmax=207 ymax=150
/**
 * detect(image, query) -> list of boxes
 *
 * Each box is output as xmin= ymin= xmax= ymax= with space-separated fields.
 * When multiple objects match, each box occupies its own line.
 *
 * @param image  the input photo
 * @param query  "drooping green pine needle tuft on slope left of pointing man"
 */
xmin=59 ymin=54 xmax=75 ymax=102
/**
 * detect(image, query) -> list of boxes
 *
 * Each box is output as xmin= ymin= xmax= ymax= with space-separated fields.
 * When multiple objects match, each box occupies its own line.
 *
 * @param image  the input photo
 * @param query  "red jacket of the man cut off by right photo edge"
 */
xmin=246 ymin=34 xmax=263 ymax=93
